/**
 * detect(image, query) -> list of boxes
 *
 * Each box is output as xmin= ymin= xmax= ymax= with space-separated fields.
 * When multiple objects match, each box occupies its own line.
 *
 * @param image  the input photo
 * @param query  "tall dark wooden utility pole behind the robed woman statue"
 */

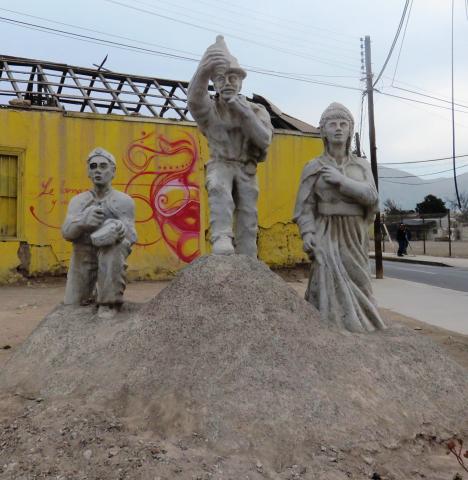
xmin=364 ymin=35 xmax=383 ymax=278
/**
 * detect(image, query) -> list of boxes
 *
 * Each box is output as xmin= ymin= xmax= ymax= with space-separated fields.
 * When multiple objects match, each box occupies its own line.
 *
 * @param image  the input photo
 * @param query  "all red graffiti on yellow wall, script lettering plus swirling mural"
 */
xmin=29 ymin=132 xmax=200 ymax=263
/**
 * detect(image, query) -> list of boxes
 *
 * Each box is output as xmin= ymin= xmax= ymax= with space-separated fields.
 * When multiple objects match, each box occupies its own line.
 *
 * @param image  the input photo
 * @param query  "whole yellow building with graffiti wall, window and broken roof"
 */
xmin=0 ymin=57 xmax=322 ymax=281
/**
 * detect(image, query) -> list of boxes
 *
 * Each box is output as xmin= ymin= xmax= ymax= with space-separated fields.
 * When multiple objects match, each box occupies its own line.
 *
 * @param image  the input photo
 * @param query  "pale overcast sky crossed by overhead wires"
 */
xmin=0 ymin=0 xmax=468 ymax=193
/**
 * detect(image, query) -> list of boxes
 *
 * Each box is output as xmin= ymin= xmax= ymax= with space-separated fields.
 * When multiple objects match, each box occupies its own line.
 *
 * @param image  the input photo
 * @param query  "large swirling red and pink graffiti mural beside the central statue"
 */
xmin=124 ymin=132 xmax=200 ymax=262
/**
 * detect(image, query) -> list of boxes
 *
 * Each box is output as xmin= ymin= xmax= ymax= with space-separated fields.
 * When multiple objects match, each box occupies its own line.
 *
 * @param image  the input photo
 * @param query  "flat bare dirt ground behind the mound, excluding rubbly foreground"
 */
xmin=0 ymin=268 xmax=468 ymax=368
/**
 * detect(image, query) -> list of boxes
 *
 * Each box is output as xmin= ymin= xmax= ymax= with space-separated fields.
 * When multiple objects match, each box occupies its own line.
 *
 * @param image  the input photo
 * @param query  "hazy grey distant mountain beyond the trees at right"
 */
xmin=379 ymin=166 xmax=468 ymax=210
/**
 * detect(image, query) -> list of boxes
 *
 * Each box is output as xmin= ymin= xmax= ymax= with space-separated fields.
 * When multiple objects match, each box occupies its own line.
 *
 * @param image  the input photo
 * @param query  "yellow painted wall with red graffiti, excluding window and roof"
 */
xmin=0 ymin=109 xmax=322 ymax=281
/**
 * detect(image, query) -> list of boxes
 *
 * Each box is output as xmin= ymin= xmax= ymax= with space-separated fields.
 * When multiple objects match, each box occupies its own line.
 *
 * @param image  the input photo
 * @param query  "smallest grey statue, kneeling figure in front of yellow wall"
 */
xmin=62 ymin=148 xmax=136 ymax=318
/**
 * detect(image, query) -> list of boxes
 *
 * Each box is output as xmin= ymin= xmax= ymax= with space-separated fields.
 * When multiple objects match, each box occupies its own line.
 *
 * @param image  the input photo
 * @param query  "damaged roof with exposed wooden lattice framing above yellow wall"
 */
xmin=0 ymin=55 xmax=318 ymax=134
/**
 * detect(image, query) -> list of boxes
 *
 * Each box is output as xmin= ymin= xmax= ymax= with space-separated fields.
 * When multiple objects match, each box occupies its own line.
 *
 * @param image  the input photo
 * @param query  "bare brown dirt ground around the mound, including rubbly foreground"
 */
xmin=0 ymin=268 xmax=468 ymax=480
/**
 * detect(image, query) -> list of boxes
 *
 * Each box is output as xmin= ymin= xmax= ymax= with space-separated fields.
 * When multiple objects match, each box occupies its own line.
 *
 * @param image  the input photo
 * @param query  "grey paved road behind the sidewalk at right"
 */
xmin=371 ymin=260 xmax=468 ymax=292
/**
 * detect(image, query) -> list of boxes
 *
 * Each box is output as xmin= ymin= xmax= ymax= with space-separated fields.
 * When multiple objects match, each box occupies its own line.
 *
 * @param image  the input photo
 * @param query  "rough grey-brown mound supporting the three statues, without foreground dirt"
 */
xmin=0 ymin=255 xmax=468 ymax=478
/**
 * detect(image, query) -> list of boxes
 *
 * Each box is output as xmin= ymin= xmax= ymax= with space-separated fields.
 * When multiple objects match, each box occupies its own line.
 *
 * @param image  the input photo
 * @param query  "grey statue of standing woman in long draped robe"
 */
xmin=294 ymin=103 xmax=385 ymax=332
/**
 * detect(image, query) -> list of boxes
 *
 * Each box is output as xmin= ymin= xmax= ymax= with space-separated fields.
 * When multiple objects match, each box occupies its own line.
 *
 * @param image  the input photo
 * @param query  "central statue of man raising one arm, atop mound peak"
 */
xmin=188 ymin=35 xmax=273 ymax=258
